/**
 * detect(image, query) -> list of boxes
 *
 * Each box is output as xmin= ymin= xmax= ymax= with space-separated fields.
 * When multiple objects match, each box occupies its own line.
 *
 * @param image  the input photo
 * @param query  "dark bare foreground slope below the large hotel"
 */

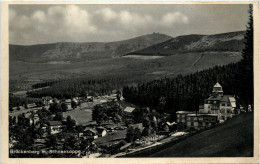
xmin=150 ymin=113 xmax=253 ymax=157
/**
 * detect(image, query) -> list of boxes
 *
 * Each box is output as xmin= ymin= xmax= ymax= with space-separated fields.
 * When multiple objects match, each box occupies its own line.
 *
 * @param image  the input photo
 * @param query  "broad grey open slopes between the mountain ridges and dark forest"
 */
xmin=10 ymin=52 xmax=241 ymax=91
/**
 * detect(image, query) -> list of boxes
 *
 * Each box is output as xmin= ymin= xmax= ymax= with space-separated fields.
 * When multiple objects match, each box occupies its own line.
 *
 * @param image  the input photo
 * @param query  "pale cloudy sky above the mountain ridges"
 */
xmin=9 ymin=4 xmax=248 ymax=45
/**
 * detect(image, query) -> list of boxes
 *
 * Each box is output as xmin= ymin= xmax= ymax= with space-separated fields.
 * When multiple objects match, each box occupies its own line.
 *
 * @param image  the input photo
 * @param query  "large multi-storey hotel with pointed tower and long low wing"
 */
xmin=176 ymin=82 xmax=240 ymax=130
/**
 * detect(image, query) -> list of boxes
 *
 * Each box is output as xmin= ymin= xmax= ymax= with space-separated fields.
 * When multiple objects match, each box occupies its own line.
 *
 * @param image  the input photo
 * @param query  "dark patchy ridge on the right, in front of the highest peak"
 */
xmin=126 ymin=31 xmax=245 ymax=56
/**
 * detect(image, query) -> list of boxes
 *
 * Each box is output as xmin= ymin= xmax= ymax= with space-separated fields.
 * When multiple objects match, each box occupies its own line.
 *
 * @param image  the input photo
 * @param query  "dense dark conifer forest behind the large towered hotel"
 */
xmin=123 ymin=63 xmax=239 ymax=113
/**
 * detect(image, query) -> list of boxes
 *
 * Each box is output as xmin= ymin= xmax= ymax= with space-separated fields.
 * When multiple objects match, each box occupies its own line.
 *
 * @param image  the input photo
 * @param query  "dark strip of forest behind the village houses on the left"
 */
xmin=27 ymin=78 xmax=124 ymax=99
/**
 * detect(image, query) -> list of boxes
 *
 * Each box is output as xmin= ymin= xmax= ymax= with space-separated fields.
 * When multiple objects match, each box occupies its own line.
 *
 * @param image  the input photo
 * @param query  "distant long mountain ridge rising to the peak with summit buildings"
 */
xmin=9 ymin=33 xmax=172 ymax=63
